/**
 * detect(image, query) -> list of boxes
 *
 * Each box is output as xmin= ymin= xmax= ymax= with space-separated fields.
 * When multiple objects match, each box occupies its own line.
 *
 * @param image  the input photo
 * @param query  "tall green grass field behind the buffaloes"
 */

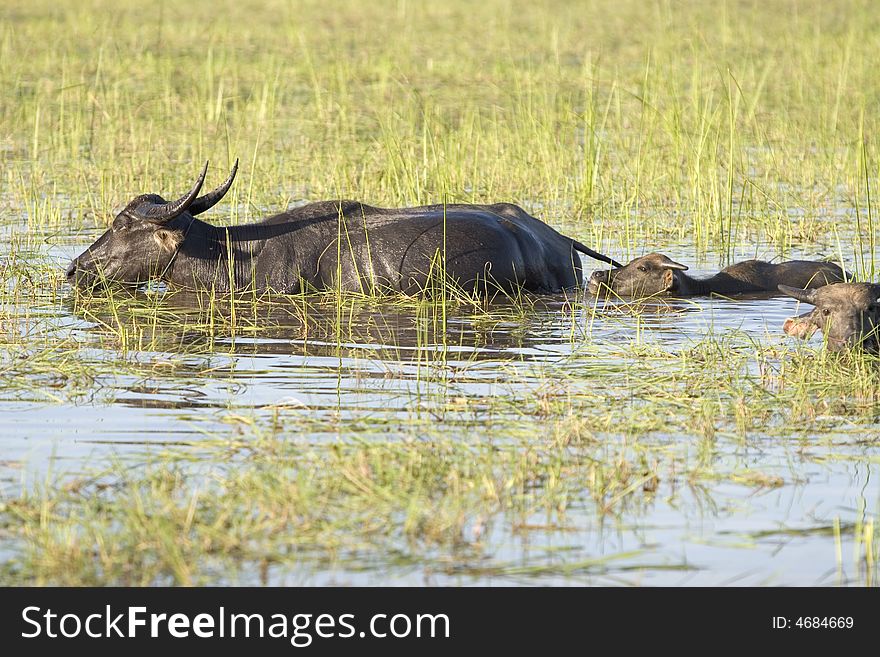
xmin=0 ymin=0 xmax=880 ymax=262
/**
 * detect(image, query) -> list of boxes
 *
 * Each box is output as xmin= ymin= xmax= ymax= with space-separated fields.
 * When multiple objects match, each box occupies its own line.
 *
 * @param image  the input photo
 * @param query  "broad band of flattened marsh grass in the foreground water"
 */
xmin=2 ymin=334 xmax=877 ymax=584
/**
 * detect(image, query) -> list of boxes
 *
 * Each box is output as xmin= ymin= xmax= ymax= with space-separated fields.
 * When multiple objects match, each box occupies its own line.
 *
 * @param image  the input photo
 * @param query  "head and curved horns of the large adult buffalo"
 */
xmin=67 ymin=160 xmax=238 ymax=289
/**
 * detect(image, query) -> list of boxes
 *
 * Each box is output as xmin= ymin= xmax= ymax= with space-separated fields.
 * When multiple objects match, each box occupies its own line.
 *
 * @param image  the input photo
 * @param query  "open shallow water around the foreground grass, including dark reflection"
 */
xmin=0 ymin=231 xmax=880 ymax=585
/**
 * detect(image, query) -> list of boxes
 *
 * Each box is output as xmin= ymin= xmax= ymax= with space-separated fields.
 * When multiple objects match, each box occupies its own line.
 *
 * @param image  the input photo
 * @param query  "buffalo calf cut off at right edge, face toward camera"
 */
xmin=779 ymin=283 xmax=880 ymax=354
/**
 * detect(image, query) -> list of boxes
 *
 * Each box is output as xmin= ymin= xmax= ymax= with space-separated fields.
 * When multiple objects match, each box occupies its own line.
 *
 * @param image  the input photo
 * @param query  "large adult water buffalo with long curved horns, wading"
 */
xmin=67 ymin=161 xmax=620 ymax=293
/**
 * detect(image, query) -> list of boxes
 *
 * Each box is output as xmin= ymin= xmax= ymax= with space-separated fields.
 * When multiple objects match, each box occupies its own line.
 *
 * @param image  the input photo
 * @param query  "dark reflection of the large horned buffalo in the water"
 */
xmin=68 ymin=293 xmax=592 ymax=360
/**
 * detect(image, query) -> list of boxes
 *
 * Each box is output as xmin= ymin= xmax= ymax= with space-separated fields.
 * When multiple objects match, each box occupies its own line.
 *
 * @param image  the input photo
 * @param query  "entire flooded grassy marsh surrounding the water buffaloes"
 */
xmin=0 ymin=0 xmax=880 ymax=585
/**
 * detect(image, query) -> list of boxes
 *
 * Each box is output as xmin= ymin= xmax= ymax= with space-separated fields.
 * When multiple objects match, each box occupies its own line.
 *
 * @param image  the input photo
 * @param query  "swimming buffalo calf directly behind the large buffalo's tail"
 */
xmin=587 ymin=253 xmax=844 ymax=297
